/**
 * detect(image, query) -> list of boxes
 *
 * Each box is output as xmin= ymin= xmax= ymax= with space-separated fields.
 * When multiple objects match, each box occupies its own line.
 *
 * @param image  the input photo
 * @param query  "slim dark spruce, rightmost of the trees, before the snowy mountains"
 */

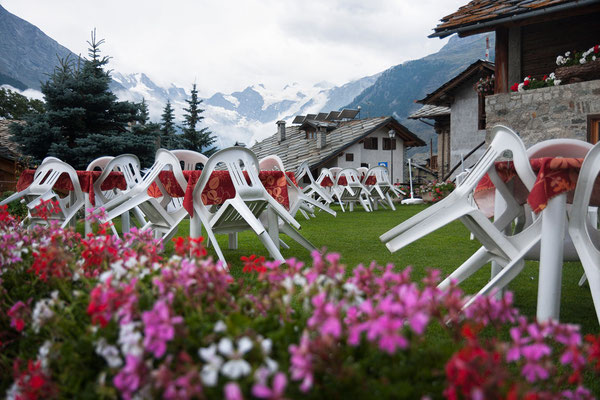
xmin=182 ymin=83 xmax=217 ymax=156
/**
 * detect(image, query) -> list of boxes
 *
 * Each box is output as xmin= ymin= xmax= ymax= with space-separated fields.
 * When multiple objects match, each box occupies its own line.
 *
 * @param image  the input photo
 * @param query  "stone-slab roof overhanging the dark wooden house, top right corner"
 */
xmin=429 ymin=0 xmax=599 ymax=38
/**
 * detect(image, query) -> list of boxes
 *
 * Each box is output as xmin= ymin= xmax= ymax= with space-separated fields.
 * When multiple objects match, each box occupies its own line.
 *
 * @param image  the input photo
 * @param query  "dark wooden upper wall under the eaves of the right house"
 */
xmin=521 ymin=12 xmax=600 ymax=79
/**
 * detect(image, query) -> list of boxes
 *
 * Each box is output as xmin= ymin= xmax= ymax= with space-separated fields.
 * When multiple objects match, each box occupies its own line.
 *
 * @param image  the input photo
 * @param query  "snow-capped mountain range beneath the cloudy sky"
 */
xmin=111 ymin=72 xmax=379 ymax=147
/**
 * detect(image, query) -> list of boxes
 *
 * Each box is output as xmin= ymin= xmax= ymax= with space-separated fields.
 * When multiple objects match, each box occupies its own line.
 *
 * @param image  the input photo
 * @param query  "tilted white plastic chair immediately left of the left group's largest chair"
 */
xmin=97 ymin=149 xmax=188 ymax=241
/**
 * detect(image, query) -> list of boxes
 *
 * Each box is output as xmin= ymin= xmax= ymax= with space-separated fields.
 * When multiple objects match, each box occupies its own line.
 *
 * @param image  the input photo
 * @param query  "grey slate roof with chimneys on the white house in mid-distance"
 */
xmin=250 ymin=117 xmax=425 ymax=171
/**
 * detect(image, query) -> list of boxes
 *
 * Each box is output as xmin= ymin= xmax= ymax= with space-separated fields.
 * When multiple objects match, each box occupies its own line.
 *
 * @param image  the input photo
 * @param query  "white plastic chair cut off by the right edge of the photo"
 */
xmin=568 ymin=143 xmax=600 ymax=322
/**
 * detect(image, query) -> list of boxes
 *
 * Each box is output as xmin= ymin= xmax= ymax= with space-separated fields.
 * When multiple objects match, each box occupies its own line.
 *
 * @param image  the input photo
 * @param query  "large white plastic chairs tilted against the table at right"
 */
xmin=380 ymin=126 xmax=600 ymax=321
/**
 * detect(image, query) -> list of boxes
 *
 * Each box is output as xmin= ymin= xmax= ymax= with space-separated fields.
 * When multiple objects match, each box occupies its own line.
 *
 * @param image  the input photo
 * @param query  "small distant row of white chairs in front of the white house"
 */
xmin=316 ymin=166 xmax=405 ymax=212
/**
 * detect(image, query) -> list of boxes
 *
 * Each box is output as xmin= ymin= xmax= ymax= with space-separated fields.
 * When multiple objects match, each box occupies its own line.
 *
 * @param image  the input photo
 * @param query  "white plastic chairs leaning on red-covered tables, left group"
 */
xmin=0 ymin=147 xmax=335 ymax=263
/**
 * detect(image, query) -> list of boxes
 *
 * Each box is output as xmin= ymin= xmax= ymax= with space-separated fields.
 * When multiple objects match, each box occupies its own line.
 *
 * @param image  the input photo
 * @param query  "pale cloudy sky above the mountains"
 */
xmin=0 ymin=0 xmax=467 ymax=96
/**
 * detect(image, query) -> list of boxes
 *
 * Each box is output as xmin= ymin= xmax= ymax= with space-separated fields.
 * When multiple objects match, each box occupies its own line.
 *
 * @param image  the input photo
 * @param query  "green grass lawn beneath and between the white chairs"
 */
xmin=115 ymin=205 xmax=598 ymax=333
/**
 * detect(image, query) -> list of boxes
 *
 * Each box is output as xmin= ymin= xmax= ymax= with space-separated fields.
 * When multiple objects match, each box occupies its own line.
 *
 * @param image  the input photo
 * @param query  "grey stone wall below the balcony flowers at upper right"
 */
xmin=485 ymin=80 xmax=600 ymax=147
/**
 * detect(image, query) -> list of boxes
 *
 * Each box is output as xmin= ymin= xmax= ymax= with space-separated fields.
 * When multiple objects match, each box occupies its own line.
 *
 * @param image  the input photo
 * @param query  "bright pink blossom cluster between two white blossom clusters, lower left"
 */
xmin=142 ymin=300 xmax=183 ymax=358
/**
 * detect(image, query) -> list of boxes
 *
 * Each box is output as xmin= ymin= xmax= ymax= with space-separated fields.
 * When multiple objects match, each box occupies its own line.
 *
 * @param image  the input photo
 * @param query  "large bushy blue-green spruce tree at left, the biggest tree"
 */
xmin=11 ymin=30 xmax=155 ymax=169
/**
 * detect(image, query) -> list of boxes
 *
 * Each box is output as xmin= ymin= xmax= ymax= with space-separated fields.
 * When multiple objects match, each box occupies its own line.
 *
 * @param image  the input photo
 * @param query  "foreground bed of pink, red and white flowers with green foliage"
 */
xmin=0 ymin=205 xmax=600 ymax=400
